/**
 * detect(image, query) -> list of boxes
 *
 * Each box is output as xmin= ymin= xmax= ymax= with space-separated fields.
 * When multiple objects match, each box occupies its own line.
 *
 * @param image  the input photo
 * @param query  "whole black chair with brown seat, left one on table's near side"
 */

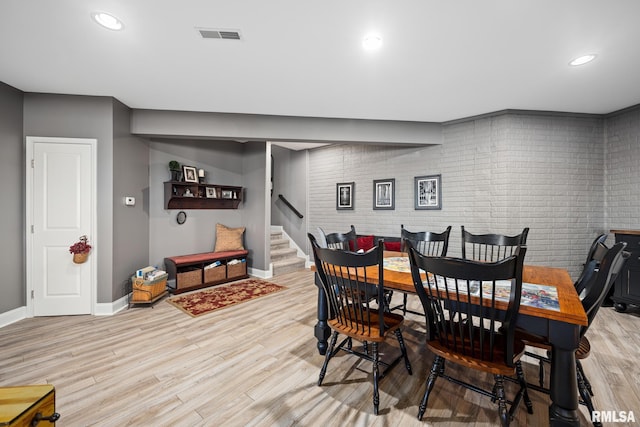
xmin=308 ymin=234 xmax=411 ymax=415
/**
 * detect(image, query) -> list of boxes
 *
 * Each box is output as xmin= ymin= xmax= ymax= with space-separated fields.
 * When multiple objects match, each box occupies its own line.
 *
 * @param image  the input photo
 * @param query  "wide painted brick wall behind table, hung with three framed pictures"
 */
xmin=309 ymin=114 xmax=604 ymax=278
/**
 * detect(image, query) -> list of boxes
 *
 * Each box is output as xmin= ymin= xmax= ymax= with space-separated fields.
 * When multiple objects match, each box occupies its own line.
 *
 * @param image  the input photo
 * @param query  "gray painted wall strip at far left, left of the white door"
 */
xmin=0 ymin=82 xmax=26 ymax=313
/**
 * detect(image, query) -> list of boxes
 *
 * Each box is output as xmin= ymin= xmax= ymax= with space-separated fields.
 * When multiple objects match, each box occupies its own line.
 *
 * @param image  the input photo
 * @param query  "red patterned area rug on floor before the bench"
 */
xmin=167 ymin=279 xmax=287 ymax=317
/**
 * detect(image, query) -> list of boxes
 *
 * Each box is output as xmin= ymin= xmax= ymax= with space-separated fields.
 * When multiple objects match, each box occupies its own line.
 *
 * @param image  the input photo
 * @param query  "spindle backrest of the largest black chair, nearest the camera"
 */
xmin=409 ymin=246 xmax=526 ymax=366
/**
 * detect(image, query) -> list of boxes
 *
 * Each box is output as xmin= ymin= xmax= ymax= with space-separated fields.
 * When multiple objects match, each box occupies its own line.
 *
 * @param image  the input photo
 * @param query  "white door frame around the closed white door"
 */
xmin=25 ymin=136 xmax=99 ymax=317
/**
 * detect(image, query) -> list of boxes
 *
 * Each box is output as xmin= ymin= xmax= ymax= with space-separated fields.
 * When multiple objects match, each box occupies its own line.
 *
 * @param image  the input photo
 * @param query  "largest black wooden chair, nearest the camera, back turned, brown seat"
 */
xmin=409 ymin=242 xmax=532 ymax=425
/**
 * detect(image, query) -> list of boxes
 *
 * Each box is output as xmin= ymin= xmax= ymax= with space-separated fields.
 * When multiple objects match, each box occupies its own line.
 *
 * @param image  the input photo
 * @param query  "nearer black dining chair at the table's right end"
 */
xmin=516 ymin=242 xmax=629 ymax=426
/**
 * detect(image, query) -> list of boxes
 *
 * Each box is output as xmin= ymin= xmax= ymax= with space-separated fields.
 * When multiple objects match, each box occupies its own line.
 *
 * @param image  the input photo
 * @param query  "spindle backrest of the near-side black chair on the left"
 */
xmin=308 ymin=234 xmax=385 ymax=337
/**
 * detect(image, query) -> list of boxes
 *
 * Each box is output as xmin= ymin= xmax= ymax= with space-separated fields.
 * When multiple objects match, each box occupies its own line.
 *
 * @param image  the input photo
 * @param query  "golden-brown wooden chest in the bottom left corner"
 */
xmin=0 ymin=384 xmax=60 ymax=427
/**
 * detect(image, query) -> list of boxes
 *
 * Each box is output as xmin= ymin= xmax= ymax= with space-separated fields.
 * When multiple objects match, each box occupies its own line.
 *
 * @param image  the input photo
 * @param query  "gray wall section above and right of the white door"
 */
xmin=24 ymin=93 xmax=120 ymax=303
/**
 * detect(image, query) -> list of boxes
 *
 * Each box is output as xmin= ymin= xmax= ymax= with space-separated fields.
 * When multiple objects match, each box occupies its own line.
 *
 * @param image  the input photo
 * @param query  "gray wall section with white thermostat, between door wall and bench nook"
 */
xmin=111 ymin=100 xmax=149 ymax=301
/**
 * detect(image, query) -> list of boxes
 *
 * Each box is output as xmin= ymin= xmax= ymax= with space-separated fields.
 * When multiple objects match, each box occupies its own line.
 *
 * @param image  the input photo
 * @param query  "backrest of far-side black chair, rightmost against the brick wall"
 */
xmin=461 ymin=225 xmax=529 ymax=262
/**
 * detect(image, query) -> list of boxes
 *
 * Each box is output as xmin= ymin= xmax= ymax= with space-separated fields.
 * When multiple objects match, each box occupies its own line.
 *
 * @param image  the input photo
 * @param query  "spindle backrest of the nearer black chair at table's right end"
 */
xmin=580 ymin=242 xmax=630 ymax=336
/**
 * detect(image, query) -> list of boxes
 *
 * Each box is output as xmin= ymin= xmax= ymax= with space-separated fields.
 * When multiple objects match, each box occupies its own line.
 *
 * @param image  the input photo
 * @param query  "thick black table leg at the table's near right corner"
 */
xmin=549 ymin=322 xmax=580 ymax=427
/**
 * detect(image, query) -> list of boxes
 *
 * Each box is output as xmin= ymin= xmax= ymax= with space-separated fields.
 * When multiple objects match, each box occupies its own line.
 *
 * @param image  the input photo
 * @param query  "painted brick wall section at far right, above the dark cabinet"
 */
xmin=605 ymin=108 xmax=640 ymax=230
